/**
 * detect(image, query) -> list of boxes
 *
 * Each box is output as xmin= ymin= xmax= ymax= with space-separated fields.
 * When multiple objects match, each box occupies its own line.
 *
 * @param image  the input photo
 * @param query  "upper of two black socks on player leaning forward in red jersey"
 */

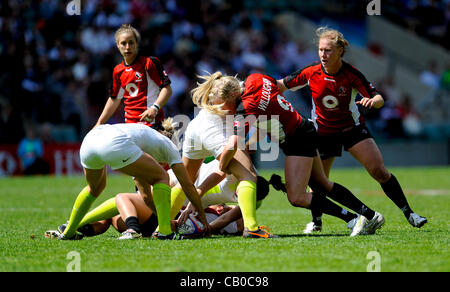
xmin=327 ymin=183 xmax=375 ymax=220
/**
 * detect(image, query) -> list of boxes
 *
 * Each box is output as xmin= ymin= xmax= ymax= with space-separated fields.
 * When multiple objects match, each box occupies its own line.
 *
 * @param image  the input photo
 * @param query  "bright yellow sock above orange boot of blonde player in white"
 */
xmin=237 ymin=180 xmax=258 ymax=231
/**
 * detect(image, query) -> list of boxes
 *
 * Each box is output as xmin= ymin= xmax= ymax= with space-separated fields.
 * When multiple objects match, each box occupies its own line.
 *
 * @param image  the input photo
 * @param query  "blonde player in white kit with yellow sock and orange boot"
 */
xmin=172 ymin=76 xmax=276 ymax=238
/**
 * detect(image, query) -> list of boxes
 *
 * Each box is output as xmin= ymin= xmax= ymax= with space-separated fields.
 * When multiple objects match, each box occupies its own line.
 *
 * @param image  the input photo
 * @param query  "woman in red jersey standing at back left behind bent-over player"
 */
xmin=95 ymin=24 xmax=172 ymax=126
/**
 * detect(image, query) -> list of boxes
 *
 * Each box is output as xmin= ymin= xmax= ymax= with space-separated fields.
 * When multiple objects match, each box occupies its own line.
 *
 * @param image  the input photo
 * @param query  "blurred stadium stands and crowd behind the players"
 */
xmin=0 ymin=0 xmax=450 ymax=176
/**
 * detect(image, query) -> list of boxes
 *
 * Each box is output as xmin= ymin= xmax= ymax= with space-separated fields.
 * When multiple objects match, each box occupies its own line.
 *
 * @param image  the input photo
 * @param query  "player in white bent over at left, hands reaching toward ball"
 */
xmin=48 ymin=124 xmax=208 ymax=239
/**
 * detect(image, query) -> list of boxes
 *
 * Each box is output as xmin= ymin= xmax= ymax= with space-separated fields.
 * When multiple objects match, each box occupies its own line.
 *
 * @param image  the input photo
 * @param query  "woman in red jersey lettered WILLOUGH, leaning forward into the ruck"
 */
xmin=197 ymin=72 xmax=381 ymax=236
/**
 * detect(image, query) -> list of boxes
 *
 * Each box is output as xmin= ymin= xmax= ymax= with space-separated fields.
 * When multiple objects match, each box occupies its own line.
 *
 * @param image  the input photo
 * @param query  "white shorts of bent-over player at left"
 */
xmin=80 ymin=125 xmax=143 ymax=169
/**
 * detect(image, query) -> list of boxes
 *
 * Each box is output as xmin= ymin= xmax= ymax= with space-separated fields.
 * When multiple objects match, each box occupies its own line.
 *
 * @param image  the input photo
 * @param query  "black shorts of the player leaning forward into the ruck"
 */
xmin=280 ymin=119 xmax=318 ymax=157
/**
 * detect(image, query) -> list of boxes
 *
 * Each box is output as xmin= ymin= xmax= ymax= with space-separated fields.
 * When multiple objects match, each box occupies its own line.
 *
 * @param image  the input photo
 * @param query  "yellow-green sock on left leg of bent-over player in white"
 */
xmin=64 ymin=187 xmax=96 ymax=238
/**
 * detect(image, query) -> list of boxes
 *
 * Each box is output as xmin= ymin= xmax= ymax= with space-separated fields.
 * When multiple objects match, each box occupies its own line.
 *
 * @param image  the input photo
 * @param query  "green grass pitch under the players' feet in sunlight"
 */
xmin=0 ymin=167 xmax=450 ymax=272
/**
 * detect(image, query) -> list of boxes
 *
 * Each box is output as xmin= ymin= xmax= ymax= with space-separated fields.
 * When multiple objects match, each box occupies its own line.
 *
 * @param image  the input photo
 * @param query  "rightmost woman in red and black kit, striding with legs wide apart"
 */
xmin=277 ymin=28 xmax=427 ymax=227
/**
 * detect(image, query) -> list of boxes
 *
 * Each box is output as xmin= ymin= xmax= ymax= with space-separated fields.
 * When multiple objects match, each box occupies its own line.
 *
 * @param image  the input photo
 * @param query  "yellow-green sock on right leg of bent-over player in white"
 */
xmin=153 ymin=183 xmax=172 ymax=235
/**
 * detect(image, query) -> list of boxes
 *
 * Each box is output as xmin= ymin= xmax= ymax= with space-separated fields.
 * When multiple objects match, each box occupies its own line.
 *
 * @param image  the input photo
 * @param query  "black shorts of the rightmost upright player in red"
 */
xmin=318 ymin=125 xmax=372 ymax=160
